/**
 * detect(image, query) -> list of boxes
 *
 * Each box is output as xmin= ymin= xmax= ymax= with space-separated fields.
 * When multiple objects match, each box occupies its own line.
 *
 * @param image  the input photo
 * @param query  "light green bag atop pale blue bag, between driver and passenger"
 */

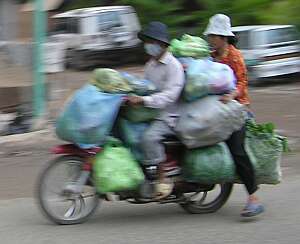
xmin=169 ymin=34 xmax=236 ymax=102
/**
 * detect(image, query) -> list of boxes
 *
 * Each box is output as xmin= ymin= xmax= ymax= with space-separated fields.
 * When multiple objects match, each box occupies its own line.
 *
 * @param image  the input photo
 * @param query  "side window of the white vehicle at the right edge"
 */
xmin=264 ymin=27 xmax=298 ymax=44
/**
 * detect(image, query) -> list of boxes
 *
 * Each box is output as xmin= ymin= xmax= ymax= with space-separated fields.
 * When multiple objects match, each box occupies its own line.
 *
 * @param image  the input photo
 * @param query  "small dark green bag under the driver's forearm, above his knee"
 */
xmin=122 ymin=106 xmax=160 ymax=123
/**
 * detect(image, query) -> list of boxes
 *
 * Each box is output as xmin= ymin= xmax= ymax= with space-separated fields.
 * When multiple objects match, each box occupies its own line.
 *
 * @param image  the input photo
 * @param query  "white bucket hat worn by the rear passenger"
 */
xmin=204 ymin=14 xmax=234 ymax=36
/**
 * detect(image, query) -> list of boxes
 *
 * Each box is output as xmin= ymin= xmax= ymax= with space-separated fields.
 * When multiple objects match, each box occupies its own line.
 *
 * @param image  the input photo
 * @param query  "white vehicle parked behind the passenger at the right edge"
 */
xmin=232 ymin=25 xmax=300 ymax=83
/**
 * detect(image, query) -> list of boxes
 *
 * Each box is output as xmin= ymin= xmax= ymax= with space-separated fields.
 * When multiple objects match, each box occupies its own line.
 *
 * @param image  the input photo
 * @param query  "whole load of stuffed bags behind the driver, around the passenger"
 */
xmin=170 ymin=35 xmax=284 ymax=184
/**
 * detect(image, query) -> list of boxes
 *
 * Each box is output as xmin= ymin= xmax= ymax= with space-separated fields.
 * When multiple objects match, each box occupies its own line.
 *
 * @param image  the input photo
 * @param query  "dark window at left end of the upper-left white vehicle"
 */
xmin=50 ymin=18 xmax=79 ymax=34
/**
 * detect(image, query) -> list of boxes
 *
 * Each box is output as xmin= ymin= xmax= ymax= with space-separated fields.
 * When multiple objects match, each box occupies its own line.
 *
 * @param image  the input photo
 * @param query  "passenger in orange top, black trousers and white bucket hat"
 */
xmin=204 ymin=14 xmax=264 ymax=217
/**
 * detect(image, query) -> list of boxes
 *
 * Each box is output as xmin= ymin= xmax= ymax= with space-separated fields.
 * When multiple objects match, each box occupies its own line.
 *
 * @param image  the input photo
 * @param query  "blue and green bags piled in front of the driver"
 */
xmin=56 ymin=69 xmax=157 ymax=193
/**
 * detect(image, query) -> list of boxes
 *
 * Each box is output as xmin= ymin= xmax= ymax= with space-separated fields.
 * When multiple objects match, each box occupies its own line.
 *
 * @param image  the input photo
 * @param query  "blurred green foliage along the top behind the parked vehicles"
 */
xmin=64 ymin=0 xmax=300 ymax=37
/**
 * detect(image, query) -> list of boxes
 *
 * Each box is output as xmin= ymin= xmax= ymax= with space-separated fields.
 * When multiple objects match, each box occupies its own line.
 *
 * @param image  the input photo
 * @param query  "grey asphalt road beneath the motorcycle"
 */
xmin=0 ymin=172 xmax=300 ymax=244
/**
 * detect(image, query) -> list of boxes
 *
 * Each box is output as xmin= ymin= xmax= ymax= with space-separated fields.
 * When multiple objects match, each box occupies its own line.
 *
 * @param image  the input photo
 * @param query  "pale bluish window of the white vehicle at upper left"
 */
xmin=98 ymin=11 xmax=121 ymax=31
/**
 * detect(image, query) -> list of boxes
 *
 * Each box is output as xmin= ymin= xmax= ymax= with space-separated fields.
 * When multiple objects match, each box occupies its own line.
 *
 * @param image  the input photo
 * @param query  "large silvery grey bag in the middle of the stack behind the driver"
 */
xmin=175 ymin=96 xmax=245 ymax=148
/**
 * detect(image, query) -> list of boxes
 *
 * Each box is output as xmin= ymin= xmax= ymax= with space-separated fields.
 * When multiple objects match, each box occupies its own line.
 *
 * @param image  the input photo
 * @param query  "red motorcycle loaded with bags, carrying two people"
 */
xmin=37 ymin=135 xmax=233 ymax=225
